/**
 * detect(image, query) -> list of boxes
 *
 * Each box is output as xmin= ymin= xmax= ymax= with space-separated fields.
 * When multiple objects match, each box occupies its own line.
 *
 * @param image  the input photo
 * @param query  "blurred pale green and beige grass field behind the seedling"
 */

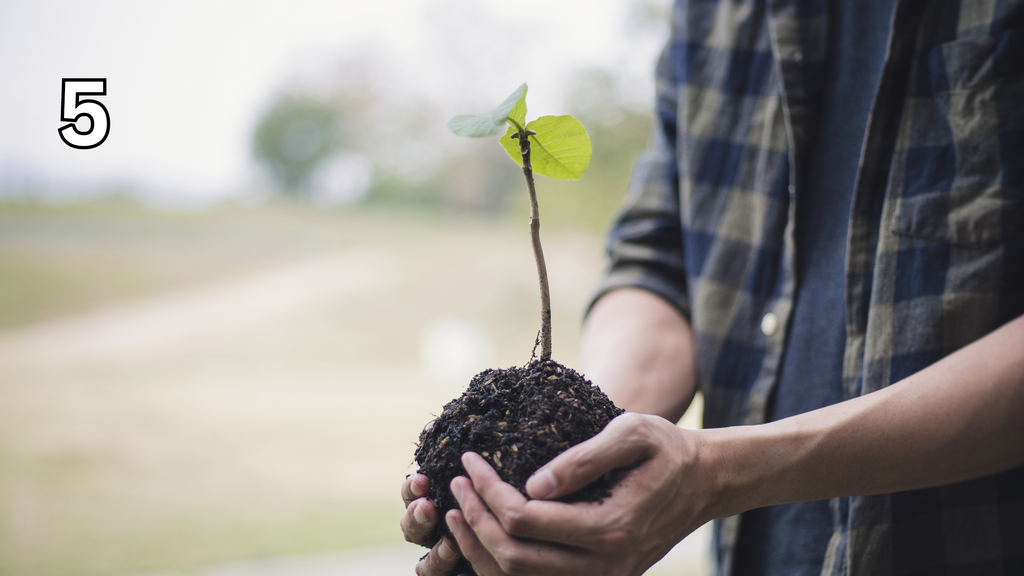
xmin=0 ymin=200 xmax=704 ymax=576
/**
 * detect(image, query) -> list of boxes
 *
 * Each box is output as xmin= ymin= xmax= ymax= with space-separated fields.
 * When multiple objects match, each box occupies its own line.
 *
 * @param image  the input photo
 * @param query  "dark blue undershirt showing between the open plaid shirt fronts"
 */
xmin=733 ymin=0 xmax=895 ymax=576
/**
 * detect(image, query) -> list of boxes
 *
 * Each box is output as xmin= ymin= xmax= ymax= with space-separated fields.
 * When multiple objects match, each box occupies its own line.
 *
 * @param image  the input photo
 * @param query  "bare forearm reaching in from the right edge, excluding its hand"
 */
xmin=701 ymin=317 xmax=1024 ymax=517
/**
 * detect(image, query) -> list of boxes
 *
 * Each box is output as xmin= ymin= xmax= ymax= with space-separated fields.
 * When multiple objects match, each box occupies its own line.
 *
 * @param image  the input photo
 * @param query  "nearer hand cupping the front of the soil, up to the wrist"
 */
xmin=445 ymin=413 xmax=714 ymax=576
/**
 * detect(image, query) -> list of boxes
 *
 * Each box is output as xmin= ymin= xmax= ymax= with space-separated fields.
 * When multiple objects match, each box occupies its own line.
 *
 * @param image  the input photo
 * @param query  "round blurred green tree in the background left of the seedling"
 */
xmin=253 ymin=94 xmax=342 ymax=197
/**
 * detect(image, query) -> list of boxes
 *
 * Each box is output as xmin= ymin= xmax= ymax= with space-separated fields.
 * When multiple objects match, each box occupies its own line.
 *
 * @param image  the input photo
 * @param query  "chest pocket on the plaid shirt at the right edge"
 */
xmin=893 ymin=31 xmax=1024 ymax=246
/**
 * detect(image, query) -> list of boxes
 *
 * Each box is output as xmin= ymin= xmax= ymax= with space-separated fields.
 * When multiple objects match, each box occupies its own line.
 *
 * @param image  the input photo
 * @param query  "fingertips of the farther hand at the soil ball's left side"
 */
xmin=399 ymin=474 xmax=460 ymax=576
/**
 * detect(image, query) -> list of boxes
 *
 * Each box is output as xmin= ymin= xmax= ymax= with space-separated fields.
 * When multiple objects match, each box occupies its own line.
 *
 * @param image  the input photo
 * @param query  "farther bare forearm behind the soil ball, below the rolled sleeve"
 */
xmin=581 ymin=288 xmax=696 ymax=422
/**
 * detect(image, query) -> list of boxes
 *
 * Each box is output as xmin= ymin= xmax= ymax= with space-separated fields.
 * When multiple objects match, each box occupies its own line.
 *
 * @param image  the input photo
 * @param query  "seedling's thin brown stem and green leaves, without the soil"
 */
xmin=447 ymin=84 xmax=592 ymax=362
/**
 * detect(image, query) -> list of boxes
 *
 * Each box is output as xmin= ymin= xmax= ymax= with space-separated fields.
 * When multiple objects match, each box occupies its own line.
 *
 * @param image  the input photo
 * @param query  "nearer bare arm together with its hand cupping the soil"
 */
xmin=446 ymin=307 xmax=1024 ymax=576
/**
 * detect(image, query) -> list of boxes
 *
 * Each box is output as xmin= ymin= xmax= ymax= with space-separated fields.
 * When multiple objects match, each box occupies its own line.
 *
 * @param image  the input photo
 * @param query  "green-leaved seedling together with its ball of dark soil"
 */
xmin=416 ymin=84 xmax=623 ymax=575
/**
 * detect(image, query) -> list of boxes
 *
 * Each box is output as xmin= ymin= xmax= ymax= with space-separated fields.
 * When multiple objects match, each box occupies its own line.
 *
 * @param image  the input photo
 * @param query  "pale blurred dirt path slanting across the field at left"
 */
xmin=0 ymin=248 xmax=397 ymax=363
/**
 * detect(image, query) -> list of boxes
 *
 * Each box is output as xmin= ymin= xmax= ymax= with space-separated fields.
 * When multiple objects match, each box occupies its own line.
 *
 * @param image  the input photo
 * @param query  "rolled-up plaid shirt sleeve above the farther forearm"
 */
xmin=587 ymin=47 xmax=690 ymax=320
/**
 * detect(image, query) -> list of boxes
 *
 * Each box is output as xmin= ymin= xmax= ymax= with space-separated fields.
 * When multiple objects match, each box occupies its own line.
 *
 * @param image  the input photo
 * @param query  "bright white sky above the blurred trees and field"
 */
xmin=0 ymin=0 xmax=666 ymax=199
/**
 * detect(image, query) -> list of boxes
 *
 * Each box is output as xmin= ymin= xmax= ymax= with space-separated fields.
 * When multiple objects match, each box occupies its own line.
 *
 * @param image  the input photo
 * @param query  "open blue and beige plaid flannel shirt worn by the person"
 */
xmin=598 ymin=0 xmax=1024 ymax=576
